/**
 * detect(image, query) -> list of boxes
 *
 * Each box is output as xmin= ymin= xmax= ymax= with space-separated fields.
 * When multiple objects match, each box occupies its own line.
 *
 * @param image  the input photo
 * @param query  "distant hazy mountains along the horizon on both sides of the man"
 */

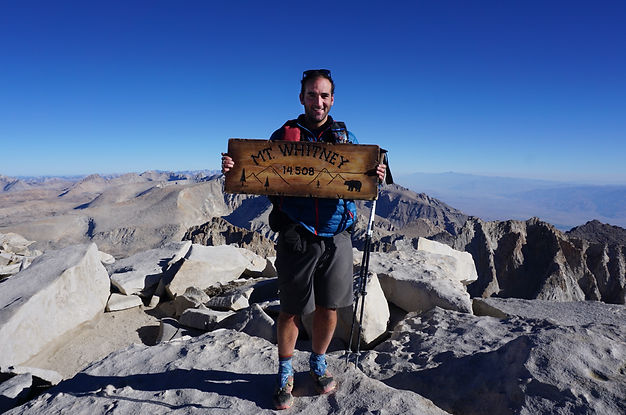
xmin=0 ymin=170 xmax=626 ymax=231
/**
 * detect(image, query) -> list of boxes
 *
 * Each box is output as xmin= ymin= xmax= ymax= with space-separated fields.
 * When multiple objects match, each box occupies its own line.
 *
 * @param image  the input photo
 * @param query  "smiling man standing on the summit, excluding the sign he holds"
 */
xmin=222 ymin=69 xmax=385 ymax=409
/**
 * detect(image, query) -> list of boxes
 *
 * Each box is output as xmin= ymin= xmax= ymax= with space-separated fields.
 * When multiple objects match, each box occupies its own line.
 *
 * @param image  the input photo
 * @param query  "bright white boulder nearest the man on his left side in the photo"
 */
xmin=166 ymin=244 xmax=267 ymax=298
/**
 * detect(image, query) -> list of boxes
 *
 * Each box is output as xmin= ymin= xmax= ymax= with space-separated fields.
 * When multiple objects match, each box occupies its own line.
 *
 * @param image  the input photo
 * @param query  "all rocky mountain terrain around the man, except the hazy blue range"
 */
xmin=0 ymin=172 xmax=626 ymax=415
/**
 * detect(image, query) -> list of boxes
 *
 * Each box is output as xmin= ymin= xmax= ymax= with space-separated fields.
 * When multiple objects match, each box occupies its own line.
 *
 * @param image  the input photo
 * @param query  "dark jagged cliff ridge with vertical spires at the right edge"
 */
xmin=433 ymin=218 xmax=626 ymax=304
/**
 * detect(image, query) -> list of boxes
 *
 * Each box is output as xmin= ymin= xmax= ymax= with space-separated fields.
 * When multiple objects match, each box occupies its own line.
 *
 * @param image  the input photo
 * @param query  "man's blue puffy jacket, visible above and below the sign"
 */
xmin=270 ymin=115 xmax=357 ymax=237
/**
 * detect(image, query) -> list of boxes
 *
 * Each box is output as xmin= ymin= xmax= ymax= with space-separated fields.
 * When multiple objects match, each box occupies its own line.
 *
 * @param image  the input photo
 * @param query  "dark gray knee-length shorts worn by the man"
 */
xmin=276 ymin=230 xmax=354 ymax=315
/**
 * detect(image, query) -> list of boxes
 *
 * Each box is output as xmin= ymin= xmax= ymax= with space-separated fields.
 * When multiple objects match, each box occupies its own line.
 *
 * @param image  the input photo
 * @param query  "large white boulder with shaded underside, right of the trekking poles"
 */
xmin=369 ymin=250 xmax=472 ymax=313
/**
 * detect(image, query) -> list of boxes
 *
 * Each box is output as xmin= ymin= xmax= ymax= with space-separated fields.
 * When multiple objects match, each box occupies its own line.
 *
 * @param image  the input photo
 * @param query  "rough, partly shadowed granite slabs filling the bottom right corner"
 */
xmin=363 ymin=299 xmax=626 ymax=415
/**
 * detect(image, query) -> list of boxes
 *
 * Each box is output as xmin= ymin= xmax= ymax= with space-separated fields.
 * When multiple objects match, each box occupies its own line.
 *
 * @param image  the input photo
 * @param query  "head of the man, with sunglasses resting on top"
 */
xmin=300 ymin=69 xmax=335 ymax=128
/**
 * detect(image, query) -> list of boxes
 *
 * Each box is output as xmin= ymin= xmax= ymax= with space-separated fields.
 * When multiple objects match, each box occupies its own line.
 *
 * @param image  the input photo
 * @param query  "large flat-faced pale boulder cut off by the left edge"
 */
xmin=0 ymin=243 xmax=110 ymax=366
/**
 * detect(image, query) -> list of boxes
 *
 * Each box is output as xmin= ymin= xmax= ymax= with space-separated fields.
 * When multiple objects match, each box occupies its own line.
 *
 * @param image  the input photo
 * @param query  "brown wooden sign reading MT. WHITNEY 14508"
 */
xmin=224 ymin=138 xmax=380 ymax=200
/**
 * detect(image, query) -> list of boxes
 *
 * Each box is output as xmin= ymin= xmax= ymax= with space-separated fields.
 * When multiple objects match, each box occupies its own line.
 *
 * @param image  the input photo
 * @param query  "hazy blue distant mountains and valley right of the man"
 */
xmin=395 ymin=172 xmax=626 ymax=230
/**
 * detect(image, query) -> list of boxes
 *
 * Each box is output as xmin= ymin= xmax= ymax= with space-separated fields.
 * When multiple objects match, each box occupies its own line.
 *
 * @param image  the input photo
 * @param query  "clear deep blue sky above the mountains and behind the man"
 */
xmin=0 ymin=0 xmax=626 ymax=184
